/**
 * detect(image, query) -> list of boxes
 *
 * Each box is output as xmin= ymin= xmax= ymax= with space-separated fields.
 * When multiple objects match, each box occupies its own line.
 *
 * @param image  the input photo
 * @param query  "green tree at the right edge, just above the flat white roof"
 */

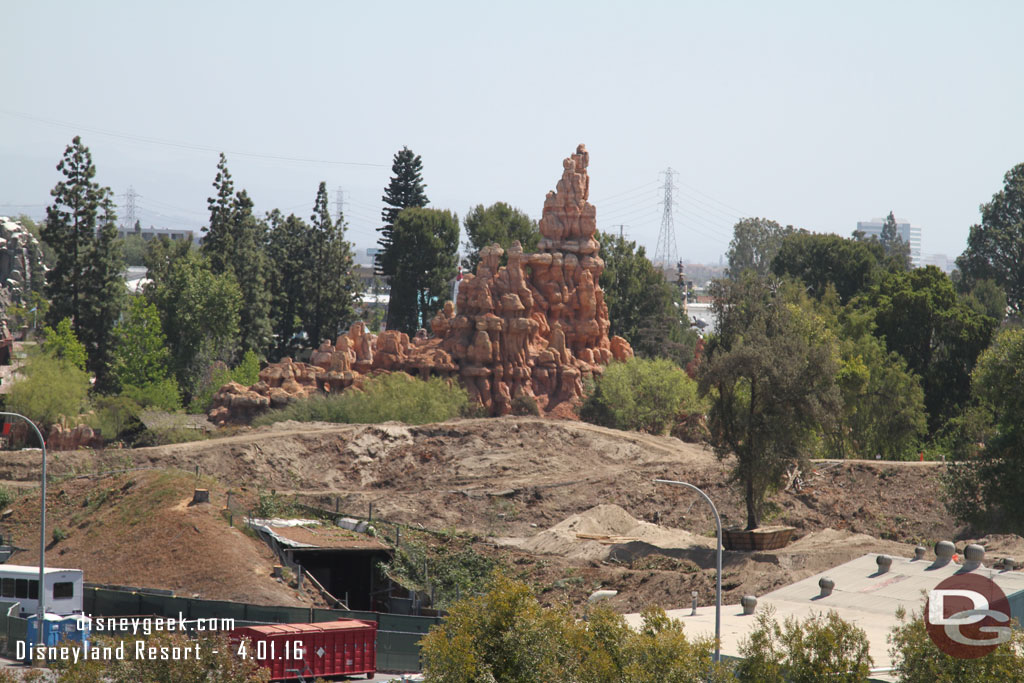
xmin=948 ymin=328 xmax=1024 ymax=531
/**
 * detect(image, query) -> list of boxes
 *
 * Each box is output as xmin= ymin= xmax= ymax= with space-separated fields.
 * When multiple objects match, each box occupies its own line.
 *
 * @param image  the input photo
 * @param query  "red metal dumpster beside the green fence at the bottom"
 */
xmin=230 ymin=618 xmax=377 ymax=681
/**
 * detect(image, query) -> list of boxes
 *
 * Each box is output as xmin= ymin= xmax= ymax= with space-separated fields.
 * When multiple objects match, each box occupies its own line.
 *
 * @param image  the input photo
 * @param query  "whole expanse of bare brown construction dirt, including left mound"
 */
xmin=0 ymin=417 xmax=1011 ymax=611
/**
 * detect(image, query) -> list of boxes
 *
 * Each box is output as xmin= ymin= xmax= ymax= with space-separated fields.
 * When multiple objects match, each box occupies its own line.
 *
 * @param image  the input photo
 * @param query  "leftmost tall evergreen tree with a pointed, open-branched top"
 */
xmin=42 ymin=135 xmax=125 ymax=389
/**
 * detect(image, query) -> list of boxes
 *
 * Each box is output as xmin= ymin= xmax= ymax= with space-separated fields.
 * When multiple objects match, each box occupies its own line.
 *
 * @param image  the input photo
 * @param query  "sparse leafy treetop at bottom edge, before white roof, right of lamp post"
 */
xmin=735 ymin=609 xmax=871 ymax=683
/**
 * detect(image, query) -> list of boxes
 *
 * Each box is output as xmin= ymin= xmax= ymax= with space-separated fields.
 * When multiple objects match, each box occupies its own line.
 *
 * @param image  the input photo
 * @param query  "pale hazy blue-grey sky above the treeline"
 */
xmin=0 ymin=0 xmax=1024 ymax=261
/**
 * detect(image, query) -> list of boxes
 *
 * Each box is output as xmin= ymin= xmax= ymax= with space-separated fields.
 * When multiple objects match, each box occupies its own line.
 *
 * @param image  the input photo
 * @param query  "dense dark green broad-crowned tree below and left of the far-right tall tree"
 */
xmin=856 ymin=265 xmax=996 ymax=434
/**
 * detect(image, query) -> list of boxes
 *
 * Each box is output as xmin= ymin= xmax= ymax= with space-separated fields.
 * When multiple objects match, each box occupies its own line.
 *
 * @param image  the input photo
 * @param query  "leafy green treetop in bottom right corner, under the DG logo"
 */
xmin=889 ymin=607 xmax=1024 ymax=683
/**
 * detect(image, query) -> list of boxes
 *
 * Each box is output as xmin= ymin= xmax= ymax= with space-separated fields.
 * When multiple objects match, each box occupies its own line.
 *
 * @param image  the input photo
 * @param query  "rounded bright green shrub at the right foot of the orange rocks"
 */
xmin=580 ymin=358 xmax=702 ymax=434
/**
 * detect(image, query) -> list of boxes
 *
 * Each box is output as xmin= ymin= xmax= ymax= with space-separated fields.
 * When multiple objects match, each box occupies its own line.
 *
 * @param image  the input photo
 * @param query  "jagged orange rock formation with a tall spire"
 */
xmin=210 ymin=144 xmax=633 ymax=422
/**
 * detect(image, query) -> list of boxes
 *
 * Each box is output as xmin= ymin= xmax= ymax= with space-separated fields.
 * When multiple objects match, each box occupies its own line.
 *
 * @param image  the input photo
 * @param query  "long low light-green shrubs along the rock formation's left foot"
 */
xmin=253 ymin=373 xmax=469 ymax=425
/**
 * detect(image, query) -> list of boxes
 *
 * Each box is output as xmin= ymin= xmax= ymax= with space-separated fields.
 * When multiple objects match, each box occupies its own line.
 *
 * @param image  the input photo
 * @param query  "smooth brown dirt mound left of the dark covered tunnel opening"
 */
xmin=2 ymin=470 xmax=310 ymax=605
